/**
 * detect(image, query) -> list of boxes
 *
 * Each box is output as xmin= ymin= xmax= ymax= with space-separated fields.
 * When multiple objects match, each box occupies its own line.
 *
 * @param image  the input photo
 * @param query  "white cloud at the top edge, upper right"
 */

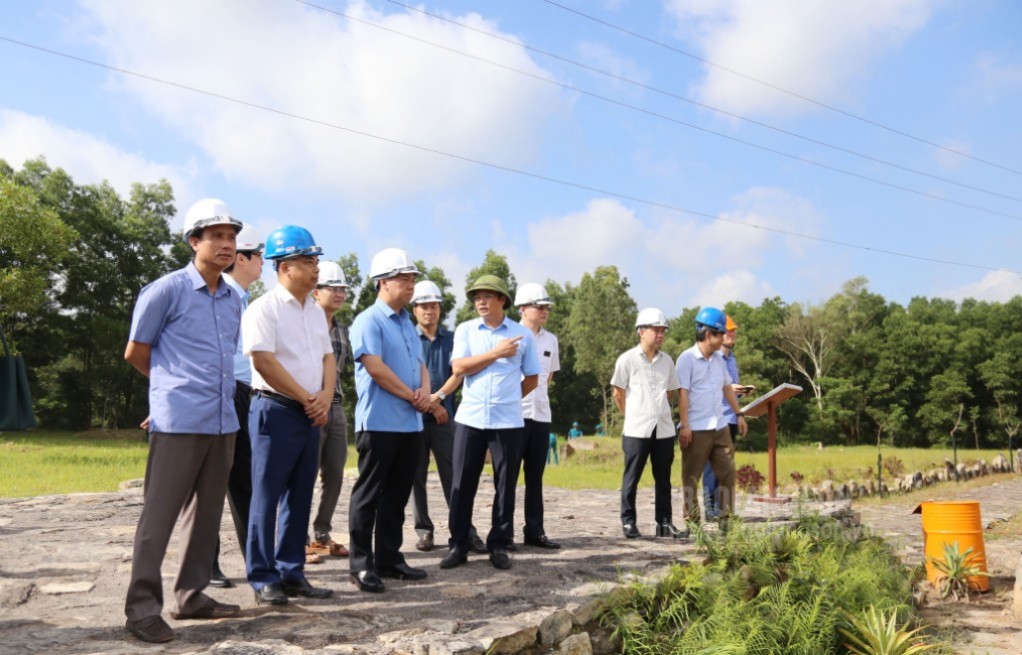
xmin=664 ymin=0 xmax=932 ymax=114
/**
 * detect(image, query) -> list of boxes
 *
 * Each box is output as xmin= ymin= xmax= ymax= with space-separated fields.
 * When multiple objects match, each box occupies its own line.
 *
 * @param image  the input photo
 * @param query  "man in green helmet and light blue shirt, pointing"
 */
xmin=440 ymin=275 xmax=542 ymax=569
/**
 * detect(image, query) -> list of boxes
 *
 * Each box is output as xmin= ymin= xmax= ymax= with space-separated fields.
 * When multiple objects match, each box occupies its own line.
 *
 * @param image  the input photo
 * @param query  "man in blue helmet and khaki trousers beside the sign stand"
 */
xmin=678 ymin=307 xmax=748 ymax=523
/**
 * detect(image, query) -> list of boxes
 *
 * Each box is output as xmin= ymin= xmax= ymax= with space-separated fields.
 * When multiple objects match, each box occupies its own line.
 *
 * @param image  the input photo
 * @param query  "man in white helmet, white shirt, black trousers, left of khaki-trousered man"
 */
xmin=610 ymin=308 xmax=688 ymax=539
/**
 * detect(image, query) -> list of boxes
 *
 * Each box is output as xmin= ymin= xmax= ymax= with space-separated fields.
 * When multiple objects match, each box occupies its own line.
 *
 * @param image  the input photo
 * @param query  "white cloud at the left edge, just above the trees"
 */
xmin=0 ymin=107 xmax=192 ymax=200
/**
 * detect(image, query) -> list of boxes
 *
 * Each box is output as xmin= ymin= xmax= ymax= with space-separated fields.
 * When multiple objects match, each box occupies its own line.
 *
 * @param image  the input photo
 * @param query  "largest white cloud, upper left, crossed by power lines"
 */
xmin=75 ymin=0 xmax=569 ymax=203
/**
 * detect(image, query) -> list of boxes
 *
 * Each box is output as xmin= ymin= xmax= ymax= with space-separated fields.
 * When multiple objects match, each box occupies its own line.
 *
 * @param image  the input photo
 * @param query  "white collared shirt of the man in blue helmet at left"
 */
xmin=241 ymin=283 xmax=333 ymax=393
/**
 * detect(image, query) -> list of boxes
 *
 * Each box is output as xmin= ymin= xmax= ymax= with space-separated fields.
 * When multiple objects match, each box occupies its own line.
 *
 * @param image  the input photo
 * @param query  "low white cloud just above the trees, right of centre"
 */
xmin=508 ymin=188 xmax=821 ymax=316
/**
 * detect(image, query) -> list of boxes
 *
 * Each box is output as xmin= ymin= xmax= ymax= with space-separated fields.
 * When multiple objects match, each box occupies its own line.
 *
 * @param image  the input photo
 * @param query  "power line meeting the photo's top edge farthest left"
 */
xmin=295 ymin=0 xmax=1022 ymax=221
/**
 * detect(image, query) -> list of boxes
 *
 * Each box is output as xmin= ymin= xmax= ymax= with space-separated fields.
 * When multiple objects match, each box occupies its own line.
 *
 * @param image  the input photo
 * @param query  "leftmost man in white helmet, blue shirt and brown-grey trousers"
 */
xmin=125 ymin=198 xmax=241 ymax=643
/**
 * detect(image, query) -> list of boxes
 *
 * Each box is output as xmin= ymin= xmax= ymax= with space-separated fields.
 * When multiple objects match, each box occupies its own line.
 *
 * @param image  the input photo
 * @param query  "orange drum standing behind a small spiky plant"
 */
xmin=913 ymin=501 xmax=990 ymax=592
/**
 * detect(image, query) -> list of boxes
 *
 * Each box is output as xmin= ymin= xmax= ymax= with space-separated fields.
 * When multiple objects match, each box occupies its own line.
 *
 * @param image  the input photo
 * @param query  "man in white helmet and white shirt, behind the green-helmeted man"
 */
xmin=515 ymin=282 xmax=561 ymax=549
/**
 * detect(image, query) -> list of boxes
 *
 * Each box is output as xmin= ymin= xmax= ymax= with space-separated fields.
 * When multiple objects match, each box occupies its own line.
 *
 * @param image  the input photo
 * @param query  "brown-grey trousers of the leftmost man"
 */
xmin=125 ymin=432 xmax=235 ymax=621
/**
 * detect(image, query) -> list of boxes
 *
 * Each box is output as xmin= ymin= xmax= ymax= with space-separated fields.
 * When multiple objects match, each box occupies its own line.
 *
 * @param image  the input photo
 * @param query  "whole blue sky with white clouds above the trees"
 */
xmin=0 ymin=0 xmax=1022 ymax=316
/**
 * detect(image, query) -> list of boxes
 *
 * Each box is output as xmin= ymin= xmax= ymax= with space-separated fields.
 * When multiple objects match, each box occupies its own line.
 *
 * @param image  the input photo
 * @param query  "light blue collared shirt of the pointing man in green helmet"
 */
xmin=451 ymin=316 xmax=543 ymax=430
